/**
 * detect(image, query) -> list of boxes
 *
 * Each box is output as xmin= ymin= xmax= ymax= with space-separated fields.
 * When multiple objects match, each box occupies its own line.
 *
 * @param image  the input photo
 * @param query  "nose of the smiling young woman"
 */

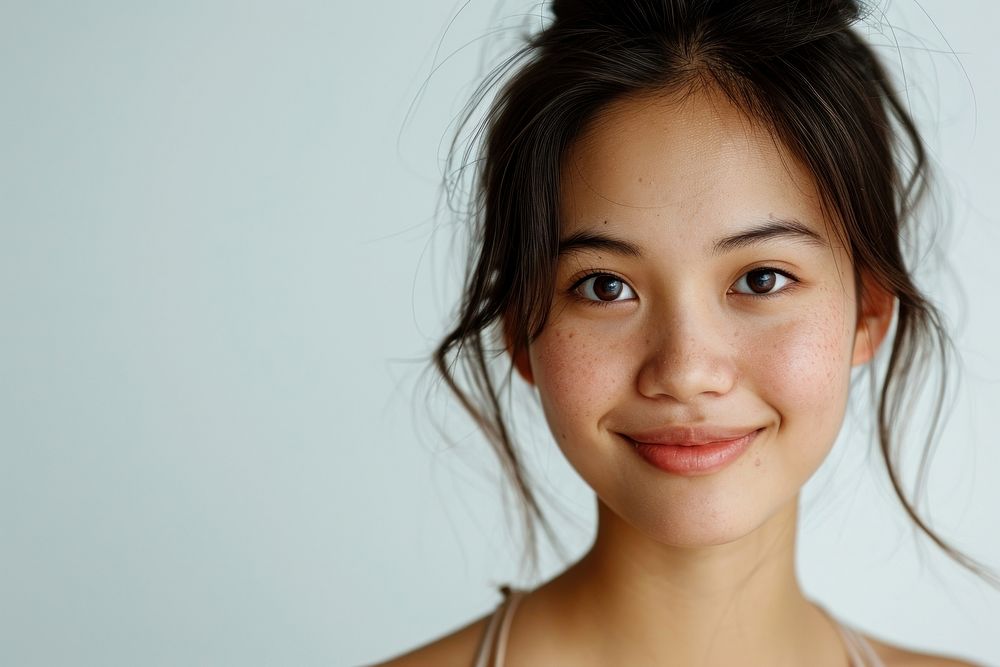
xmin=637 ymin=304 xmax=738 ymax=403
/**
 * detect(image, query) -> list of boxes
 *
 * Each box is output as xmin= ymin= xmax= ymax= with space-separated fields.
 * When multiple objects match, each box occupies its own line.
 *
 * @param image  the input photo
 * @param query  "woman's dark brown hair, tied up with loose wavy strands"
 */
xmin=434 ymin=0 xmax=984 ymax=574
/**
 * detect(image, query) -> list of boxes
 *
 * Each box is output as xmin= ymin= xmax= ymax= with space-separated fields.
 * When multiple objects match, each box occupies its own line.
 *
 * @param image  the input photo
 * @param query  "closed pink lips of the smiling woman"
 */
xmin=620 ymin=427 xmax=763 ymax=477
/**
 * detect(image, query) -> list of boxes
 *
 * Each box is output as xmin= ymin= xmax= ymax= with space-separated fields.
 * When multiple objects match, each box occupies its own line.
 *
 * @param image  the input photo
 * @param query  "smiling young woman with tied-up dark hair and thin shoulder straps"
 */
xmin=372 ymin=1 xmax=978 ymax=666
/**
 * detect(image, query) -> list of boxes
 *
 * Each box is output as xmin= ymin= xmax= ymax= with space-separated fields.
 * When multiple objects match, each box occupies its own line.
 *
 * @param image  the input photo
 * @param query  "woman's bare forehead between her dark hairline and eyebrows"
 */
xmin=561 ymin=89 xmax=829 ymax=245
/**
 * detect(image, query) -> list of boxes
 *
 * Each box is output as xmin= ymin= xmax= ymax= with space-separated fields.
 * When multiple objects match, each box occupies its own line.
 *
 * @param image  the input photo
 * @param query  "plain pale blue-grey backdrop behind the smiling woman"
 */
xmin=0 ymin=0 xmax=1000 ymax=666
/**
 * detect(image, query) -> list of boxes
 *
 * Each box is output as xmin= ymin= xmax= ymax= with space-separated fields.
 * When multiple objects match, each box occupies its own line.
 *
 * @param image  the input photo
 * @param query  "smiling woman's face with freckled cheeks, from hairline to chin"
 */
xmin=515 ymin=87 xmax=884 ymax=546
